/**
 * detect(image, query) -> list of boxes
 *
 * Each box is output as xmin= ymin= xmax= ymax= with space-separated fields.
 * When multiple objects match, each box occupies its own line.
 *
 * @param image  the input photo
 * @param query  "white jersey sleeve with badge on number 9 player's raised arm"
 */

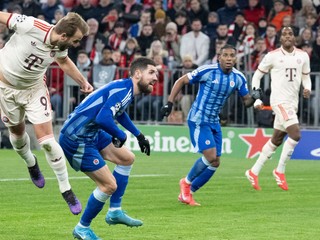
xmin=7 ymin=13 xmax=34 ymax=34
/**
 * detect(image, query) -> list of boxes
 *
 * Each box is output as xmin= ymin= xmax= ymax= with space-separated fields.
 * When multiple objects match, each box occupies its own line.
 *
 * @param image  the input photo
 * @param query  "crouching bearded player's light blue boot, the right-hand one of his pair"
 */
xmin=106 ymin=209 xmax=143 ymax=227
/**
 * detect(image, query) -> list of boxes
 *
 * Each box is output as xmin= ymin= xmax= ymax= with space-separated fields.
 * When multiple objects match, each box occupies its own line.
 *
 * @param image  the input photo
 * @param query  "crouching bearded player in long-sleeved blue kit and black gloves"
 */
xmin=59 ymin=57 xmax=158 ymax=239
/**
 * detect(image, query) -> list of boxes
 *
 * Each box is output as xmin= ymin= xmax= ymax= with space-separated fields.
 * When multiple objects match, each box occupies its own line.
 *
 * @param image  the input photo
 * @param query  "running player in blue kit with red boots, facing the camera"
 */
xmin=161 ymin=45 xmax=261 ymax=206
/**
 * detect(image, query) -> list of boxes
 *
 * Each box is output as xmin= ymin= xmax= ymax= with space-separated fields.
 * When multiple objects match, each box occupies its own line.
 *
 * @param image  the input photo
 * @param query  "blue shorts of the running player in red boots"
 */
xmin=188 ymin=121 xmax=222 ymax=157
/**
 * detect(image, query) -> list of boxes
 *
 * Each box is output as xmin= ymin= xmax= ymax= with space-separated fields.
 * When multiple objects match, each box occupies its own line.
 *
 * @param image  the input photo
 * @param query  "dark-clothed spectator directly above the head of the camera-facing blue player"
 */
xmin=209 ymin=24 xmax=236 ymax=59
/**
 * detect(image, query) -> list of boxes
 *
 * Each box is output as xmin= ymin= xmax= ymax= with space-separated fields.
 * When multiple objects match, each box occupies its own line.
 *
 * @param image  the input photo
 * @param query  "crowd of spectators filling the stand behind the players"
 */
xmin=0 ymin=0 xmax=320 ymax=124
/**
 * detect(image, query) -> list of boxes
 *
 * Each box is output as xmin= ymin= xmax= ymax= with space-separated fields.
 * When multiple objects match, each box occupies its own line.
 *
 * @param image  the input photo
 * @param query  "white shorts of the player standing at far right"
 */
xmin=272 ymin=104 xmax=299 ymax=132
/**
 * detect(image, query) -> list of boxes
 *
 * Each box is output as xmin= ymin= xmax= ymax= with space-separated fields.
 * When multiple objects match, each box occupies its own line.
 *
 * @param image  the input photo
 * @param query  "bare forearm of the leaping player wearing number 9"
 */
xmin=56 ymin=56 xmax=93 ymax=93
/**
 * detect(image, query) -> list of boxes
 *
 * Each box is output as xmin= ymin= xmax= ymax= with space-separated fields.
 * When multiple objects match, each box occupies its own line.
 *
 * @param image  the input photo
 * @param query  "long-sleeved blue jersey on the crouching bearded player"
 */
xmin=61 ymin=78 xmax=140 ymax=143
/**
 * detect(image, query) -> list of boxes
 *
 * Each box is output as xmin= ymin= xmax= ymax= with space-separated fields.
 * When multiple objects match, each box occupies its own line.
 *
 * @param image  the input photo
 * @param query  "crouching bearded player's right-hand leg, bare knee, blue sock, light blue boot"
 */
xmin=101 ymin=144 xmax=143 ymax=227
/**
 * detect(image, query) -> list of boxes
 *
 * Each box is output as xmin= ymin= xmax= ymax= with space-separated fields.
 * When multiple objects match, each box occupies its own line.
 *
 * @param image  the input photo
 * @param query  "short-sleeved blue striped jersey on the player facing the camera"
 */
xmin=187 ymin=63 xmax=249 ymax=123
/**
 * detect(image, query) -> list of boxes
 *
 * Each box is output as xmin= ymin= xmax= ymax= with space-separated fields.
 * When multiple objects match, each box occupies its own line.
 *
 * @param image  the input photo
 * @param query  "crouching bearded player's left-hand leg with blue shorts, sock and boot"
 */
xmin=59 ymin=133 xmax=117 ymax=239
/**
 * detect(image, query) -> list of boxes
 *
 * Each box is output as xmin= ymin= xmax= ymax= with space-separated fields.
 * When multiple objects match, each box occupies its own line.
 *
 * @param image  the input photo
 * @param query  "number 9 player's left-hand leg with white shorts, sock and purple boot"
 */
xmin=0 ymin=85 xmax=45 ymax=188
